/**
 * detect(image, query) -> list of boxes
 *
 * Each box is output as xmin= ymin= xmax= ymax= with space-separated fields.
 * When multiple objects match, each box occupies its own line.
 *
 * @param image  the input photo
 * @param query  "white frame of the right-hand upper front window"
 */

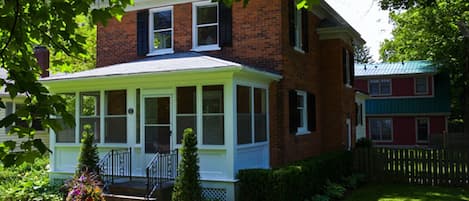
xmin=191 ymin=1 xmax=221 ymax=52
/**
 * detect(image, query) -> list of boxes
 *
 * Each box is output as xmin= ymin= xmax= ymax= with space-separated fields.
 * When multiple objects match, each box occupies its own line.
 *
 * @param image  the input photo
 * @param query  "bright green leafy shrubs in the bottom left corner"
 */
xmin=0 ymin=157 xmax=62 ymax=201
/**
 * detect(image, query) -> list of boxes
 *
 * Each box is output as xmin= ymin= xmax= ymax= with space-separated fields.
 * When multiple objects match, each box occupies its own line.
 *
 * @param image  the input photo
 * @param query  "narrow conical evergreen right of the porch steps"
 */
xmin=171 ymin=128 xmax=202 ymax=201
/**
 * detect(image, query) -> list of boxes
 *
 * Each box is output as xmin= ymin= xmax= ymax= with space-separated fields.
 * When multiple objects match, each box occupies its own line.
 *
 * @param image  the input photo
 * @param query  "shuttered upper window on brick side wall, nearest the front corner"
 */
xmin=289 ymin=0 xmax=308 ymax=52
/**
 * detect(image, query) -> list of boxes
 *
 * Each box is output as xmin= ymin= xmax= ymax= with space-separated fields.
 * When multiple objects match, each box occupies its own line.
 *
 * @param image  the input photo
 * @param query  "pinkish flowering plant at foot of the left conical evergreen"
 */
xmin=66 ymin=171 xmax=105 ymax=201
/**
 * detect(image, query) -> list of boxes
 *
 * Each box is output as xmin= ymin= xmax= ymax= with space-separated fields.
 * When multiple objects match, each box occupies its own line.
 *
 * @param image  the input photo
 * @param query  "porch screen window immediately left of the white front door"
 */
xmin=104 ymin=90 xmax=127 ymax=143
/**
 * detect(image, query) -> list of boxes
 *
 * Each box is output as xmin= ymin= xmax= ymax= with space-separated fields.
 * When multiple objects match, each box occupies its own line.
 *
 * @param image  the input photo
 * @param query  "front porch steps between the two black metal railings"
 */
xmin=104 ymin=179 xmax=174 ymax=201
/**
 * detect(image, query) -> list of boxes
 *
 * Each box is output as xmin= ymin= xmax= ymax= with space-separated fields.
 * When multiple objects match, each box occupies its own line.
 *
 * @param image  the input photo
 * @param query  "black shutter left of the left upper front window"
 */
xmin=137 ymin=10 xmax=148 ymax=56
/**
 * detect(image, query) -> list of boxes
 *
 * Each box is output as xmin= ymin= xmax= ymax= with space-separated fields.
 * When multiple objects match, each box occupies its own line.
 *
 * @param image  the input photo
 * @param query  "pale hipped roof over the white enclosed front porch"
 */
xmin=41 ymin=52 xmax=281 ymax=82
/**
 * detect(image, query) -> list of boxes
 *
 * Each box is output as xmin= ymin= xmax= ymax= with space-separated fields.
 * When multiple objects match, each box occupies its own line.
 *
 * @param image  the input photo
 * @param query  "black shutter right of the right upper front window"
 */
xmin=218 ymin=1 xmax=233 ymax=47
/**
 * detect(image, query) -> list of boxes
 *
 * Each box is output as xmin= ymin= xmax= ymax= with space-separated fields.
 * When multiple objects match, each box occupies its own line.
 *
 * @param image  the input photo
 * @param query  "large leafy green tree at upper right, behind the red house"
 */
xmin=380 ymin=0 xmax=469 ymax=134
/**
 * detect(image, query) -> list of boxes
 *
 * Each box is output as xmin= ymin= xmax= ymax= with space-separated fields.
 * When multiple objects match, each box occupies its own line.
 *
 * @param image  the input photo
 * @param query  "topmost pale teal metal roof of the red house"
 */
xmin=355 ymin=60 xmax=437 ymax=77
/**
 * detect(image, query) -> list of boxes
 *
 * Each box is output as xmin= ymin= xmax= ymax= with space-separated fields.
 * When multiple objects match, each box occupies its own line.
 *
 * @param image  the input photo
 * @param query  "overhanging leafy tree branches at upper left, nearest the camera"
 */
xmin=0 ymin=0 xmax=133 ymax=166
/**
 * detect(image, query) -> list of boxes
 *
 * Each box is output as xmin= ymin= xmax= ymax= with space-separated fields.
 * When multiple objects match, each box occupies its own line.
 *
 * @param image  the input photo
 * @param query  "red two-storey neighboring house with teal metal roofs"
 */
xmin=355 ymin=61 xmax=450 ymax=146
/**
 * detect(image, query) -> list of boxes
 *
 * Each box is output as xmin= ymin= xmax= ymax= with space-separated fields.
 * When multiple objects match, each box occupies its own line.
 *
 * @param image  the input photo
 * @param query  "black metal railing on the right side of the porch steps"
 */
xmin=146 ymin=149 xmax=178 ymax=197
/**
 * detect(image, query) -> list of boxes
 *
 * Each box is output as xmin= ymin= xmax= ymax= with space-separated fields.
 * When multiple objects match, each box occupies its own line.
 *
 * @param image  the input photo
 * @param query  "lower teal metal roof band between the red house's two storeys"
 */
xmin=366 ymin=74 xmax=451 ymax=115
